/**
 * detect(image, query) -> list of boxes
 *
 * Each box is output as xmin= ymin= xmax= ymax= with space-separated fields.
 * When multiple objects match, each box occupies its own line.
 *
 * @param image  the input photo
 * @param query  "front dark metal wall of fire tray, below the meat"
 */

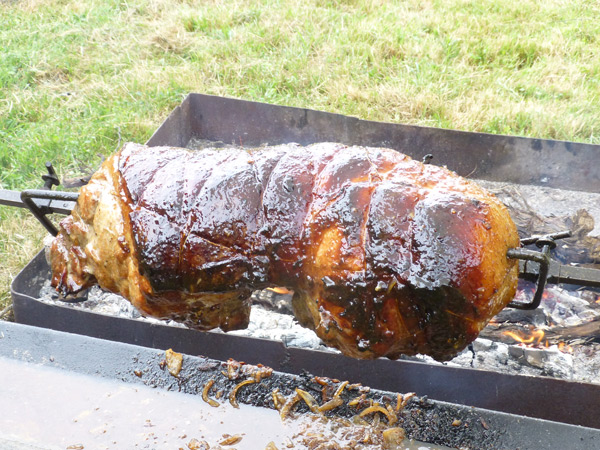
xmin=11 ymin=252 xmax=600 ymax=429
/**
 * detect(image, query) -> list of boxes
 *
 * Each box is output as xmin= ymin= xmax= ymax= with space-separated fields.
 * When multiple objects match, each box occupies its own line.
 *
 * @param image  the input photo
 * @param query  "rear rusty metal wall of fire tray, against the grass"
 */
xmin=147 ymin=93 xmax=600 ymax=193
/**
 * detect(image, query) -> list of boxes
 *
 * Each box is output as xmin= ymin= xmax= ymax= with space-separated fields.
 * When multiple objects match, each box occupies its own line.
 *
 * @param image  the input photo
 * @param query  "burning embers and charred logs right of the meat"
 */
xmin=428 ymin=282 xmax=600 ymax=383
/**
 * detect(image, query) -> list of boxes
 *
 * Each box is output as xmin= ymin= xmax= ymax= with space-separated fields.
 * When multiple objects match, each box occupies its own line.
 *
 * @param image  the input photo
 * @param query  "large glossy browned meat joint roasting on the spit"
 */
xmin=50 ymin=143 xmax=519 ymax=360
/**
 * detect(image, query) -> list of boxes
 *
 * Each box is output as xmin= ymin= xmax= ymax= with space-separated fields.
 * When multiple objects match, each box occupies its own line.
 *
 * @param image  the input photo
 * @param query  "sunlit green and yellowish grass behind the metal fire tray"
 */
xmin=0 ymin=0 xmax=600 ymax=309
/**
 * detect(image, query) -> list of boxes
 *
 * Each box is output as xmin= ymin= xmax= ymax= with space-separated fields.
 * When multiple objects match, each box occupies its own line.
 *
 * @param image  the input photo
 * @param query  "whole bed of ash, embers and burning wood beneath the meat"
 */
xmin=40 ymin=281 xmax=600 ymax=383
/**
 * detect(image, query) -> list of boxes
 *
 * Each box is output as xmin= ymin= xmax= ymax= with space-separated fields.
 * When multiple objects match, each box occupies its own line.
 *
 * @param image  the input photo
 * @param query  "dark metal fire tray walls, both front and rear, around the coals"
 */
xmin=11 ymin=94 xmax=600 ymax=428
